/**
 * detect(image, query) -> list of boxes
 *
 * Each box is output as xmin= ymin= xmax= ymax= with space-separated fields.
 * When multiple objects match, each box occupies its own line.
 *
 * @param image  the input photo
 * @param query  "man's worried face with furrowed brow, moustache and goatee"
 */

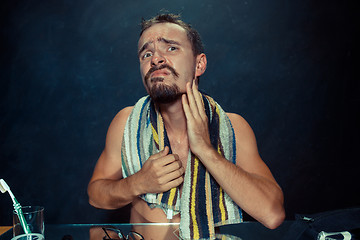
xmin=138 ymin=23 xmax=196 ymax=103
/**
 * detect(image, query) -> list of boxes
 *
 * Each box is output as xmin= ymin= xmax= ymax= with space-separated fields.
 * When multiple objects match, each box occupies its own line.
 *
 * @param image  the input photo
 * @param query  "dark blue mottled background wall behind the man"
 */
xmin=0 ymin=0 xmax=360 ymax=225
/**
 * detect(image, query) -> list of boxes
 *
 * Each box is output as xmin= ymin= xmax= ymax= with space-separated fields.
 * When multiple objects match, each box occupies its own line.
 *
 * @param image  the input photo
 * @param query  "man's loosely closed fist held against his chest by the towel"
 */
xmin=137 ymin=147 xmax=185 ymax=194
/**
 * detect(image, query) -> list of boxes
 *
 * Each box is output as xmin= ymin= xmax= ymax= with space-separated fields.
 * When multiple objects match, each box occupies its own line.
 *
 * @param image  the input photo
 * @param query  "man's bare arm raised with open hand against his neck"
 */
xmin=183 ymin=80 xmax=285 ymax=229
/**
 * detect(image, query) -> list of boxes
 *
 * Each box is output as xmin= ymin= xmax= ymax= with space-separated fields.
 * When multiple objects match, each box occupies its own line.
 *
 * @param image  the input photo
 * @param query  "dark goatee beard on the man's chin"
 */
xmin=149 ymin=78 xmax=182 ymax=104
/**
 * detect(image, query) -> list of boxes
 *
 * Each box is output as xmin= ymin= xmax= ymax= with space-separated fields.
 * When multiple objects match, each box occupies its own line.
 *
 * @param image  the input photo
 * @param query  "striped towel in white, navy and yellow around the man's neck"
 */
xmin=121 ymin=95 xmax=242 ymax=239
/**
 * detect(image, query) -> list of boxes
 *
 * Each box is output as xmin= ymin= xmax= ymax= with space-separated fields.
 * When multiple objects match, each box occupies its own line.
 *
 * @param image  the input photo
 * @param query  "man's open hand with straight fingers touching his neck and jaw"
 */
xmin=182 ymin=80 xmax=212 ymax=156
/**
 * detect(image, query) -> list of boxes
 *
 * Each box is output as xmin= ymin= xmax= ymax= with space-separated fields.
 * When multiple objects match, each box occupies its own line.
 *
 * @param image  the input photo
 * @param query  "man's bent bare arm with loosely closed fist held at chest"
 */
xmin=88 ymin=107 xmax=185 ymax=209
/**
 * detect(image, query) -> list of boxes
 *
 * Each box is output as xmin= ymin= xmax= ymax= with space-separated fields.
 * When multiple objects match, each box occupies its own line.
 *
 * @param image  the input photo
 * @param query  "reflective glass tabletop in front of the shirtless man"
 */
xmin=0 ymin=221 xmax=292 ymax=240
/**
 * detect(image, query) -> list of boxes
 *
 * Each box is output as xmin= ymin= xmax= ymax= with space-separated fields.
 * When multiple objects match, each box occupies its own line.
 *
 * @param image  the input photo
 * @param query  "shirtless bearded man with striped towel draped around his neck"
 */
xmin=88 ymin=14 xmax=285 ymax=238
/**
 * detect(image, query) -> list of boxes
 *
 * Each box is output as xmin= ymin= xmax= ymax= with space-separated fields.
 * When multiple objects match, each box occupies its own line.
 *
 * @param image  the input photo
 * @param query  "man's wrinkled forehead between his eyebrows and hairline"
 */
xmin=138 ymin=23 xmax=191 ymax=49
